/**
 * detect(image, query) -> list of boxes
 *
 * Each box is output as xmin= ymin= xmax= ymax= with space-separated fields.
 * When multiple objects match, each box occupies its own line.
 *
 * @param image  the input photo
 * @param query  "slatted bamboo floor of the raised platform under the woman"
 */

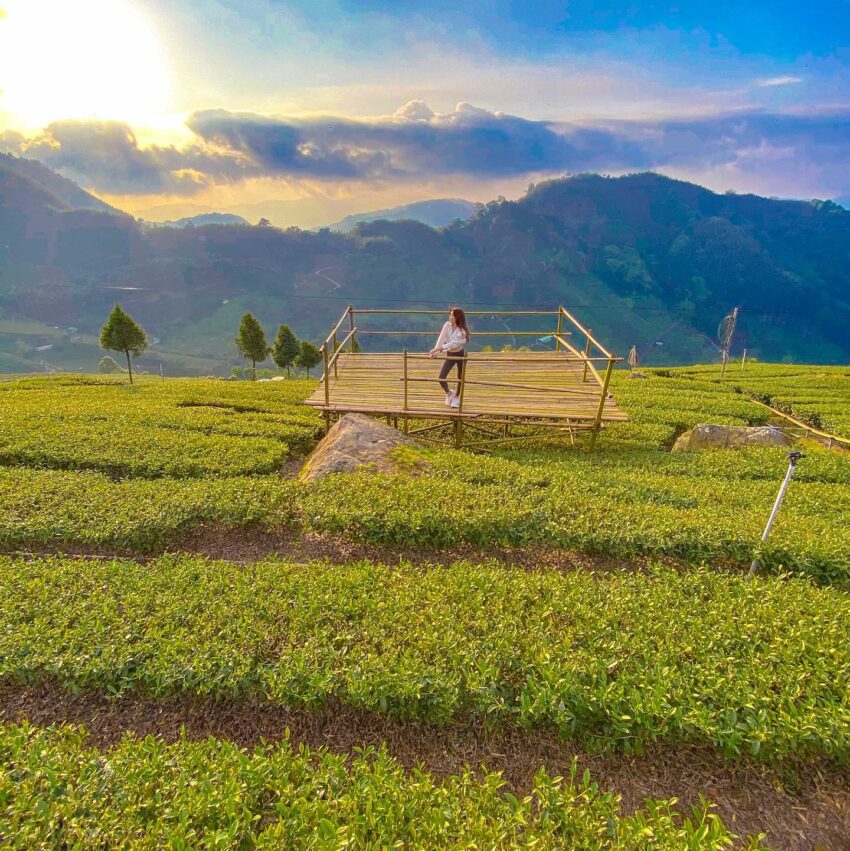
xmin=306 ymin=352 xmax=627 ymax=428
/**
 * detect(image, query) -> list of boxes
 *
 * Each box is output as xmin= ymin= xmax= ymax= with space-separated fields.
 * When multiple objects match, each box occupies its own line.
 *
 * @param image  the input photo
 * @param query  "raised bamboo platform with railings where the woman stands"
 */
xmin=306 ymin=305 xmax=627 ymax=450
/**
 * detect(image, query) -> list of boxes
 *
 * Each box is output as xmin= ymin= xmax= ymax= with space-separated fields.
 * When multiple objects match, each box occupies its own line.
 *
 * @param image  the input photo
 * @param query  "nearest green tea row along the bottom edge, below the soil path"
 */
xmin=0 ymin=724 xmax=748 ymax=851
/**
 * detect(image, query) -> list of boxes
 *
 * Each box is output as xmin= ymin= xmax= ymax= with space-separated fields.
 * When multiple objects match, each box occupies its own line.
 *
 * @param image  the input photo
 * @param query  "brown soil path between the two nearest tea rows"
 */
xmin=0 ymin=681 xmax=850 ymax=851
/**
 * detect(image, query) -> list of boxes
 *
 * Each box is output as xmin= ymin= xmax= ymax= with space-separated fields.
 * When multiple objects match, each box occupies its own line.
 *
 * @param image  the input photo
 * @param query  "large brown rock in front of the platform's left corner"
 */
xmin=301 ymin=414 xmax=425 ymax=482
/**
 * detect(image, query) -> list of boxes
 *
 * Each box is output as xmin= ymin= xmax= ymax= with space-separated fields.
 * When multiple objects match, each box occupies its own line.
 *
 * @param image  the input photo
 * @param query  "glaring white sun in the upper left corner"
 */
xmin=0 ymin=0 xmax=171 ymax=129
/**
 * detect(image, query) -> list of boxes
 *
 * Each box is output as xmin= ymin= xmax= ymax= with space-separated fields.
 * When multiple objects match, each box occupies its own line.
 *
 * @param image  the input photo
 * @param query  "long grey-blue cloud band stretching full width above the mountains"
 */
xmin=0 ymin=100 xmax=850 ymax=203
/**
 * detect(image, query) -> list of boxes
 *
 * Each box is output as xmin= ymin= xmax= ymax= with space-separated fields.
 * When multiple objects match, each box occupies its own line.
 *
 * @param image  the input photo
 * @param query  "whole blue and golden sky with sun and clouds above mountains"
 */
xmin=0 ymin=0 xmax=850 ymax=227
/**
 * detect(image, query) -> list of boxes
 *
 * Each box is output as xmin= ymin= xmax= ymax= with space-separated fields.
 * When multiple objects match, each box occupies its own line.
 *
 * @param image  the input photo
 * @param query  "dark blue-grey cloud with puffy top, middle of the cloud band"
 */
xmin=188 ymin=101 xmax=647 ymax=180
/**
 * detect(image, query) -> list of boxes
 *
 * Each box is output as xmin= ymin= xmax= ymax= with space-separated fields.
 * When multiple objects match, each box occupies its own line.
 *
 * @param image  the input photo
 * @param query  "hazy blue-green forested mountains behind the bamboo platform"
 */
xmin=0 ymin=160 xmax=850 ymax=372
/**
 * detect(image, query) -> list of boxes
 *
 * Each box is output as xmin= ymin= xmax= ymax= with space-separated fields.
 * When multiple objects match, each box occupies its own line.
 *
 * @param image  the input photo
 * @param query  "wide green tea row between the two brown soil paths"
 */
xmin=0 ymin=556 xmax=850 ymax=761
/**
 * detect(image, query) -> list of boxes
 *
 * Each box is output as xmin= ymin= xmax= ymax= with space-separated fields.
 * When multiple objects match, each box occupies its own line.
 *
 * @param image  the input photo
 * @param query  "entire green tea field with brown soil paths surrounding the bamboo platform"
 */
xmin=0 ymin=366 xmax=850 ymax=849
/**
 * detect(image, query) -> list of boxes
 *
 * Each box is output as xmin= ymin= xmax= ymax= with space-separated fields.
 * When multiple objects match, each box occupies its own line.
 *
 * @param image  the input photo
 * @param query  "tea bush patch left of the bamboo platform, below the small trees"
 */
xmin=0 ymin=379 xmax=321 ymax=478
